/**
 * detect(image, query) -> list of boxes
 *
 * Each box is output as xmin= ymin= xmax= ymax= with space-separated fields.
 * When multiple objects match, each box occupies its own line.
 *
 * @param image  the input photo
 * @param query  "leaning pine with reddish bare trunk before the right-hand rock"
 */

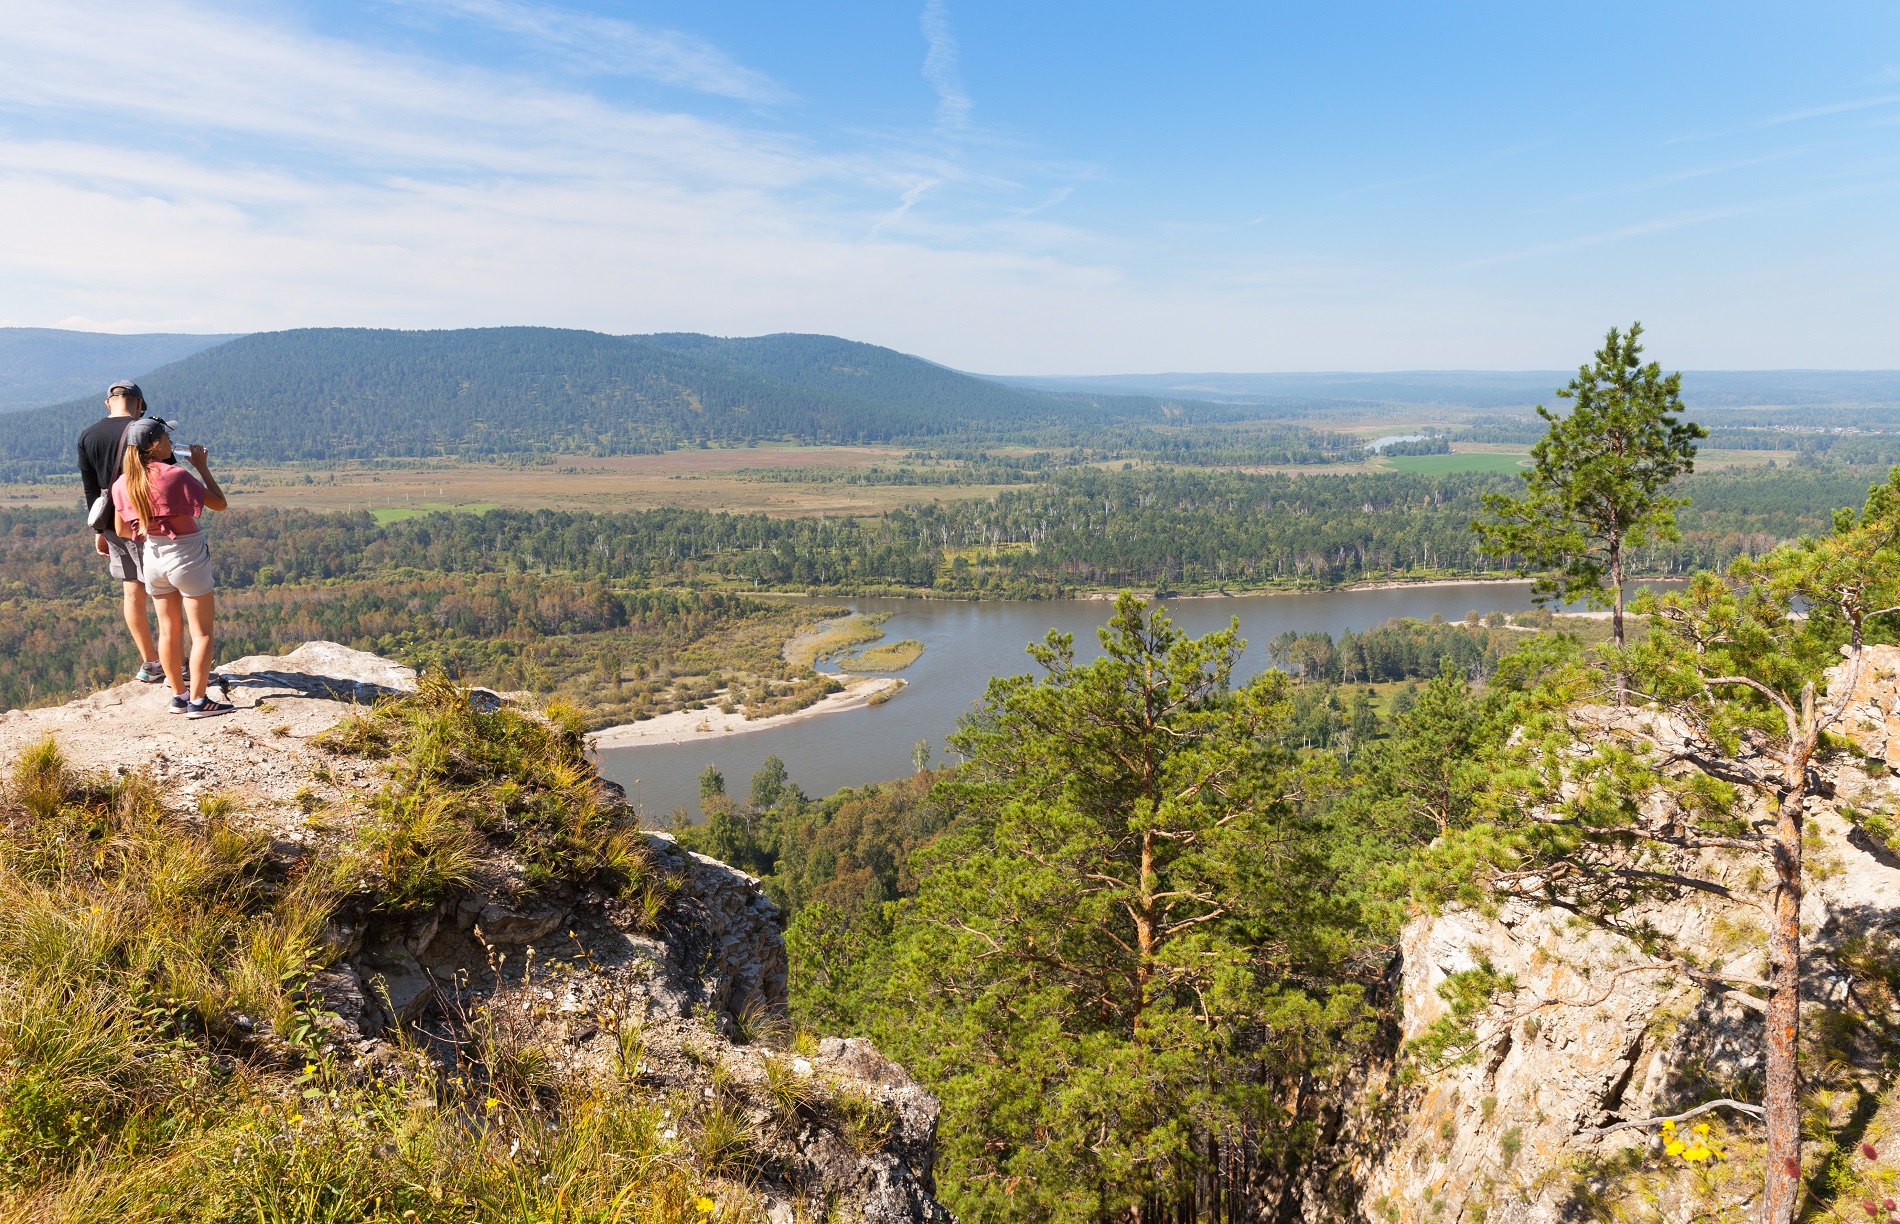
xmin=1412 ymin=469 xmax=1900 ymax=1224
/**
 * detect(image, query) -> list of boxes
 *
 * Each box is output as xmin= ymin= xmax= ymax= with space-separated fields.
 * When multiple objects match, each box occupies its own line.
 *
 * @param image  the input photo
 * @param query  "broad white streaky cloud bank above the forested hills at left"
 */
xmin=0 ymin=0 xmax=1148 ymax=369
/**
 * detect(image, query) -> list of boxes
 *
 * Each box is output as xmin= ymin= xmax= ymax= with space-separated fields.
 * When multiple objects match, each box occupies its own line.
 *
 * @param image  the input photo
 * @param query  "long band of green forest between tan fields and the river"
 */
xmin=0 ymin=468 xmax=1868 ymax=599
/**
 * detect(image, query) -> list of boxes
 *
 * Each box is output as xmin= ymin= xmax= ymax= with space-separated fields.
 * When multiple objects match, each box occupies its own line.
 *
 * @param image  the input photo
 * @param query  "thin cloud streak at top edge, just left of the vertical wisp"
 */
xmin=399 ymin=0 xmax=787 ymax=103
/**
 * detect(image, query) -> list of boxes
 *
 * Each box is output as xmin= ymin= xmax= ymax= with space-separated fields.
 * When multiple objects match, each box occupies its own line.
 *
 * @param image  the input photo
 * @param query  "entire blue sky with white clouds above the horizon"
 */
xmin=0 ymin=0 xmax=1900 ymax=373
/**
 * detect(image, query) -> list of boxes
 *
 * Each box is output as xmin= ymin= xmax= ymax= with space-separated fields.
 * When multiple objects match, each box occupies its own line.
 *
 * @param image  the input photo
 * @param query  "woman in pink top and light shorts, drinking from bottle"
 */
xmin=112 ymin=416 xmax=232 ymax=718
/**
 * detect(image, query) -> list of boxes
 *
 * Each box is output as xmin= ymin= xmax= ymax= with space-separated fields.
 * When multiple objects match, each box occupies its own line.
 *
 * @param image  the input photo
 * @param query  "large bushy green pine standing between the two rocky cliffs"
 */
xmin=794 ymin=595 xmax=1364 ymax=1222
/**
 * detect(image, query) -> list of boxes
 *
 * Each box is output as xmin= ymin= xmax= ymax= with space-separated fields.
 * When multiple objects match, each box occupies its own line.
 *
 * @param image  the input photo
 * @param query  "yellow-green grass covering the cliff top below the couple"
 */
xmin=0 ymin=688 xmax=718 ymax=1224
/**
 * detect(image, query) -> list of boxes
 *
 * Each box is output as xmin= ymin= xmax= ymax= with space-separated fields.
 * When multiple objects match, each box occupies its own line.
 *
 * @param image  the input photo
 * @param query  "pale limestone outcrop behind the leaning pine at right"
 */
xmin=1352 ymin=646 xmax=1900 ymax=1224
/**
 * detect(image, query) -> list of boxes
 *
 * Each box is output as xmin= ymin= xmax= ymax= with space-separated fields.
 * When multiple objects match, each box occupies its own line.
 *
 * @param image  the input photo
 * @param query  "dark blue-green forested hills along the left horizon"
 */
xmin=0 ymin=327 xmax=1180 ymax=477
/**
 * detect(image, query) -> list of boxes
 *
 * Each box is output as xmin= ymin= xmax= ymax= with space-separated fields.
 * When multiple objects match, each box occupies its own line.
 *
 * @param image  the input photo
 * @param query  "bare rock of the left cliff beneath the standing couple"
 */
xmin=0 ymin=642 xmax=950 ymax=1224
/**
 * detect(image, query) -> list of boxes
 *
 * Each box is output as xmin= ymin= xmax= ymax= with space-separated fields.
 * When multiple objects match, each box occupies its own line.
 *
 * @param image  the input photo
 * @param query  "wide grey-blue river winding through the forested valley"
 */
xmin=599 ymin=582 xmax=1649 ymax=825
